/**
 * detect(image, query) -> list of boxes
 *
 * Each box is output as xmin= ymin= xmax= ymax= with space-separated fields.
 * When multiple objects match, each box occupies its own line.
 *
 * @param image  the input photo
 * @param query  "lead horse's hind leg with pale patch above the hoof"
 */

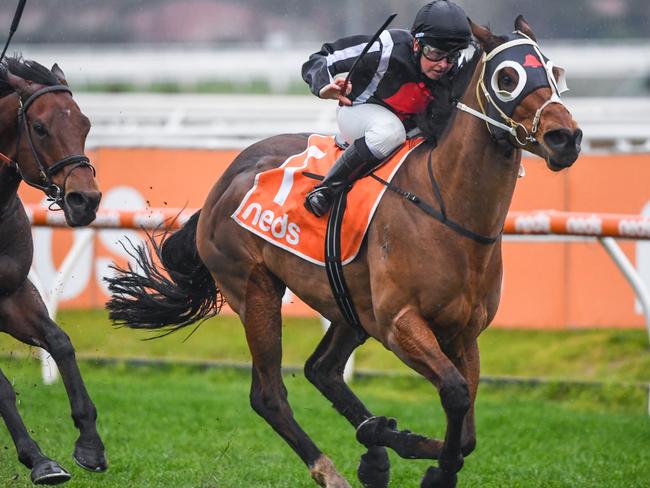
xmin=240 ymin=268 xmax=349 ymax=488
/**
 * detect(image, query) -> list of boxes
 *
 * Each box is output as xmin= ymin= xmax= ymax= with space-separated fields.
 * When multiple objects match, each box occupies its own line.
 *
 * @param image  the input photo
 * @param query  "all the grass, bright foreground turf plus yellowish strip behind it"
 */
xmin=0 ymin=311 xmax=650 ymax=488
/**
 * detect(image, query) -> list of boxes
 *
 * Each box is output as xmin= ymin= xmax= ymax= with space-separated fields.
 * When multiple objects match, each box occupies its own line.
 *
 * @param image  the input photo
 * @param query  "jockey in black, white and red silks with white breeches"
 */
xmin=302 ymin=0 xmax=472 ymax=217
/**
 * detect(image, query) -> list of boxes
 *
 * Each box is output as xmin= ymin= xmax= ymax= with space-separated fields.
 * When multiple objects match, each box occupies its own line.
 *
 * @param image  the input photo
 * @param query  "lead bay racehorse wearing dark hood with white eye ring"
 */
xmin=108 ymin=16 xmax=582 ymax=487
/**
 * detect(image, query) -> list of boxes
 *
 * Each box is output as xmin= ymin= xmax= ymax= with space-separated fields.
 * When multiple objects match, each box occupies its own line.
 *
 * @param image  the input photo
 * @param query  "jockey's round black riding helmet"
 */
xmin=411 ymin=0 xmax=472 ymax=51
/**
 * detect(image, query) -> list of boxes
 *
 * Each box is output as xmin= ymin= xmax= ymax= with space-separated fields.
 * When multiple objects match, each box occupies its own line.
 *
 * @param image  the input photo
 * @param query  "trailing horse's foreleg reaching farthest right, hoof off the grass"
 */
xmin=0 ymin=281 xmax=107 ymax=472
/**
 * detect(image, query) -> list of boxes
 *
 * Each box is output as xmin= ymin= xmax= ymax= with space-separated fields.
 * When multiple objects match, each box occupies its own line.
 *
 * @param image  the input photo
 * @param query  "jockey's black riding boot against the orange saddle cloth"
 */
xmin=305 ymin=138 xmax=381 ymax=217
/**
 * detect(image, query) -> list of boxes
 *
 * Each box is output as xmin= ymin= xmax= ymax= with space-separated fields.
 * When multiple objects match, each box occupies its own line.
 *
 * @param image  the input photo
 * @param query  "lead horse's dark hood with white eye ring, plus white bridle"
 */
xmin=456 ymin=31 xmax=568 ymax=147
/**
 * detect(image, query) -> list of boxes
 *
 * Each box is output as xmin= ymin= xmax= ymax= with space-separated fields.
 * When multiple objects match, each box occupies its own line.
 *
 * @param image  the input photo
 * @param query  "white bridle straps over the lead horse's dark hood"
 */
xmin=456 ymin=31 xmax=564 ymax=147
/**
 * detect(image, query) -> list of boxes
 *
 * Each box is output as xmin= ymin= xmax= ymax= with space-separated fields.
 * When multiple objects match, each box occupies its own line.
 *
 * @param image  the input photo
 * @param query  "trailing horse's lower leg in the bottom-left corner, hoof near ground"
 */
xmin=0 ymin=371 xmax=70 ymax=485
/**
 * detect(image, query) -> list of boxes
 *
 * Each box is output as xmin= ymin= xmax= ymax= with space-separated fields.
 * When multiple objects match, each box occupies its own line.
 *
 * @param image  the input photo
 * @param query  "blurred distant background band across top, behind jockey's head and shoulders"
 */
xmin=5 ymin=0 xmax=650 ymax=96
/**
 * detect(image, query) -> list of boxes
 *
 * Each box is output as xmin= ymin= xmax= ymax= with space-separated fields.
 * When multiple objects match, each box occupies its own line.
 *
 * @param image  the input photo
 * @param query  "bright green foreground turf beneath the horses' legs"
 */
xmin=0 ymin=359 xmax=650 ymax=488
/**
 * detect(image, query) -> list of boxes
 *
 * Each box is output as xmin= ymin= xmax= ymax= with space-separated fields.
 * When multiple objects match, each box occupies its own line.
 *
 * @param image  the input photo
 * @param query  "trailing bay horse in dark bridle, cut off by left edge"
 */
xmin=0 ymin=57 xmax=107 ymax=484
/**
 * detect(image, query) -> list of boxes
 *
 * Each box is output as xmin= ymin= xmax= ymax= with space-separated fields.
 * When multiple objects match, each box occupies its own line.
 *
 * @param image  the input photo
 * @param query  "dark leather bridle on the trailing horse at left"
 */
xmin=0 ymin=85 xmax=95 ymax=209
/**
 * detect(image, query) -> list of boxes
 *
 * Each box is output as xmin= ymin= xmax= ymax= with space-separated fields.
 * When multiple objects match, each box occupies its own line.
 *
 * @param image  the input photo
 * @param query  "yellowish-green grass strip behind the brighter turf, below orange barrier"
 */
xmin=0 ymin=310 xmax=650 ymax=383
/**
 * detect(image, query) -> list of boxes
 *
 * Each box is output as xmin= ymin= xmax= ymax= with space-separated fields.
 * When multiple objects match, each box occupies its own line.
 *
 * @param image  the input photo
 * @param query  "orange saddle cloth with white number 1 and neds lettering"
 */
xmin=232 ymin=134 xmax=422 ymax=266
